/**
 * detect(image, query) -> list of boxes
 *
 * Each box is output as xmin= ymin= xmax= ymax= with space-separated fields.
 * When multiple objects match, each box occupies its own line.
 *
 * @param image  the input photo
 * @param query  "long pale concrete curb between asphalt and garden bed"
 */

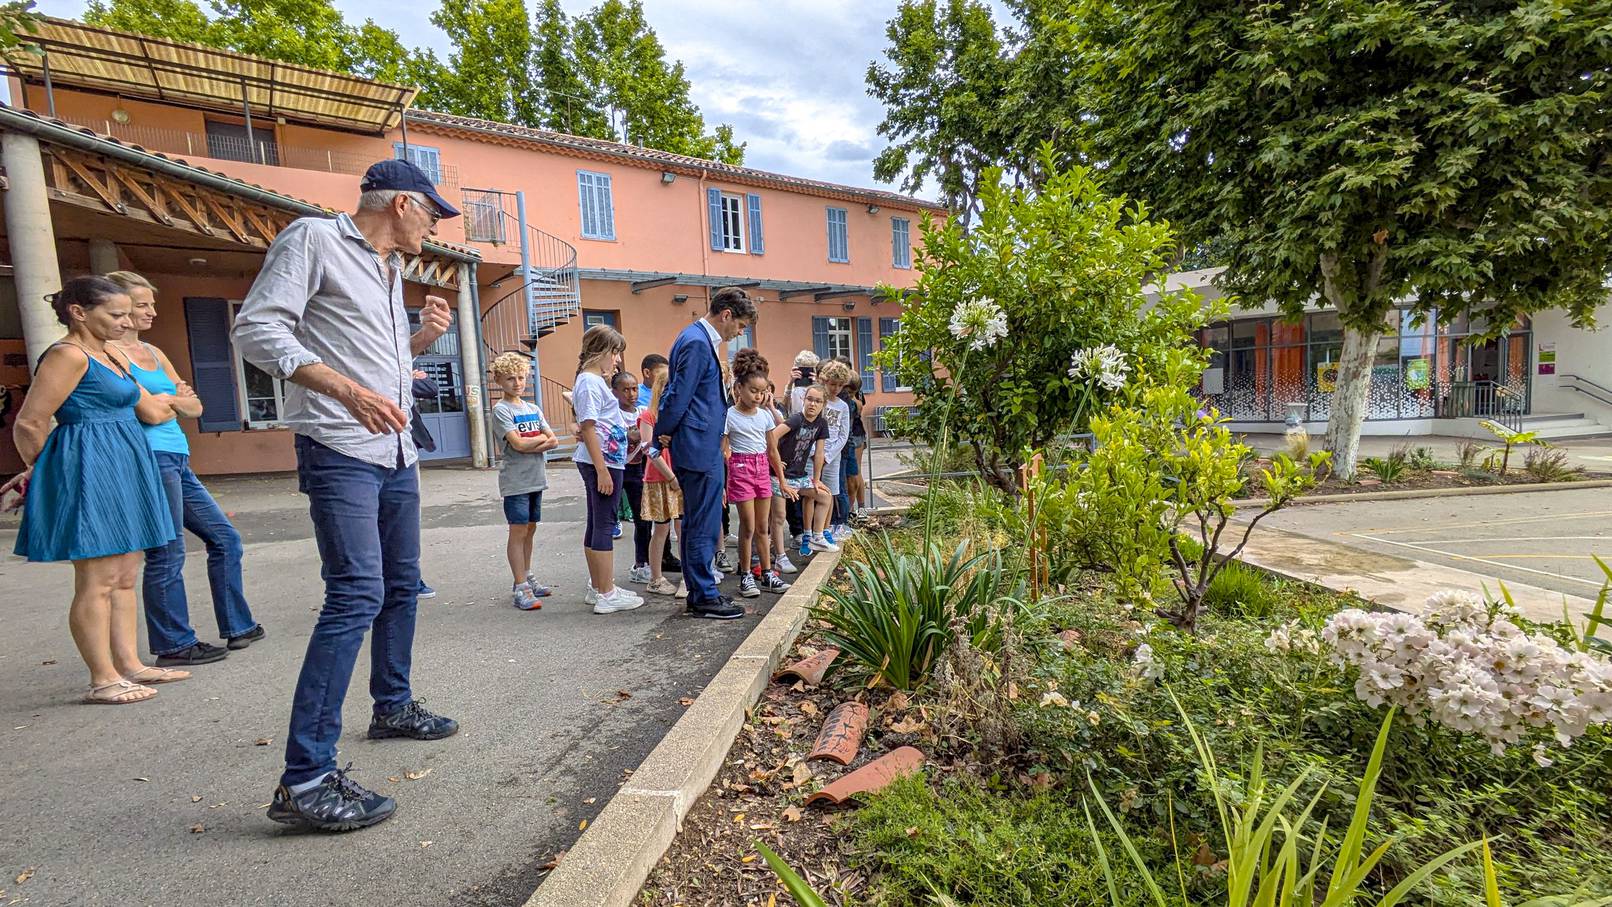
xmin=526 ymin=553 xmax=840 ymax=907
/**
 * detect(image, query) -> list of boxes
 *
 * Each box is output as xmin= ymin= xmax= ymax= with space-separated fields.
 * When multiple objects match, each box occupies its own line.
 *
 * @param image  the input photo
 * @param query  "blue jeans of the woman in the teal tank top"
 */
xmin=142 ymin=451 xmax=258 ymax=656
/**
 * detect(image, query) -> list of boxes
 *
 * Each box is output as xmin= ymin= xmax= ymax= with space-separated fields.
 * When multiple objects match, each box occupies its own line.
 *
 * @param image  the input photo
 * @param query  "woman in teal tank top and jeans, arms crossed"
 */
xmin=106 ymin=271 xmax=264 ymax=667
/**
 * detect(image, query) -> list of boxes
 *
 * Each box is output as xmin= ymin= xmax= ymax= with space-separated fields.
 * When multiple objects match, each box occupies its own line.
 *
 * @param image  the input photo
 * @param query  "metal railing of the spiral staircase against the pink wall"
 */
xmin=464 ymin=188 xmax=582 ymax=359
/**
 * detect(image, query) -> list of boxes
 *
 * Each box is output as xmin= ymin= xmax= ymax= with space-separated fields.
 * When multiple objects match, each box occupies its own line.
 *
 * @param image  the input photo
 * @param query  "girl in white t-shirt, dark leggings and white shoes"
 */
xmin=571 ymin=324 xmax=643 ymax=614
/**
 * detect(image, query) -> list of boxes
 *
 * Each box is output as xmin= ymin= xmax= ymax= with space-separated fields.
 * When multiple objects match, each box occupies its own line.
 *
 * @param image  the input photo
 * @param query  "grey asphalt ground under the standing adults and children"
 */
xmin=0 ymin=462 xmax=818 ymax=907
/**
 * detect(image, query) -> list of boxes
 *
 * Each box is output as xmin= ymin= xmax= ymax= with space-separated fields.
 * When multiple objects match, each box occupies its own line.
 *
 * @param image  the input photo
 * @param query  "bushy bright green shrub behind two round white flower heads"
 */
xmin=875 ymin=150 xmax=1212 ymax=491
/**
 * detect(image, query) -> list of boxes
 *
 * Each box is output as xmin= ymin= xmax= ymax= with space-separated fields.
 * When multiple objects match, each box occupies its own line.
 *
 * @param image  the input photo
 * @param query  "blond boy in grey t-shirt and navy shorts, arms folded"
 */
xmin=490 ymin=353 xmax=559 ymax=611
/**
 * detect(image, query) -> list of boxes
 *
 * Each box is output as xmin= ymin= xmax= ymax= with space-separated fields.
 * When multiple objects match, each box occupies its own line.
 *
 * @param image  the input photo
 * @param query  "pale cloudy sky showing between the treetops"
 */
xmin=39 ymin=0 xmax=1001 ymax=198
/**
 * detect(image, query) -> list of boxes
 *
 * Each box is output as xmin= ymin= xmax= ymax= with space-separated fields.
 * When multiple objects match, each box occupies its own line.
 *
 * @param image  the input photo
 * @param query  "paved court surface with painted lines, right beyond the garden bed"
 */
xmin=1254 ymin=485 xmax=1612 ymax=604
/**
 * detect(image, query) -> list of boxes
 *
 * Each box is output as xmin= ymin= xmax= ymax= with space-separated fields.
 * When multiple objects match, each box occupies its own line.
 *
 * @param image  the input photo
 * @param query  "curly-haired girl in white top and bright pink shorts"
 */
xmin=722 ymin=348 xmax=795 ymax=598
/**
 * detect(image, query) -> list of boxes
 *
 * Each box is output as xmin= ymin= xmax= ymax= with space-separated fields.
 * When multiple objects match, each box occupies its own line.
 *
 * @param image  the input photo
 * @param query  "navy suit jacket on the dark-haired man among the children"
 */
xmin=654 ymin=322 xmax=727 ymax=472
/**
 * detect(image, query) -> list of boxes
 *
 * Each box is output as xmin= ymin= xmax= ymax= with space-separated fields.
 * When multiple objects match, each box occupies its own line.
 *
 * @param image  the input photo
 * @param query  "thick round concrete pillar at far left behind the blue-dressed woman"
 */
xmin=0 ymin=132 xmax=68 ymax=374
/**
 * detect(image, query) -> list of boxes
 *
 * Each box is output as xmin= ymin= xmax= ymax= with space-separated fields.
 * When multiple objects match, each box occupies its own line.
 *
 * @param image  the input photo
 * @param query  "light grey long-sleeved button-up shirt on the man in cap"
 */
xmin=234 ymin=214 xmax=418 ymax=467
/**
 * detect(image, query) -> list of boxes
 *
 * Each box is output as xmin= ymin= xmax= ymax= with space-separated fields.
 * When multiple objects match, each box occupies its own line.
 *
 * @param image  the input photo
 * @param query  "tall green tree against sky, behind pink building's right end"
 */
xmin=867 ymin=0 xmax=1012 ymax=222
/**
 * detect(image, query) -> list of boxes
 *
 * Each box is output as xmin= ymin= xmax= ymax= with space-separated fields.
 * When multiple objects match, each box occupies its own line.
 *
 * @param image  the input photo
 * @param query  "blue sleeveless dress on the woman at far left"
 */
xmin=16 ymin=346 xmax=174 ymax=561
